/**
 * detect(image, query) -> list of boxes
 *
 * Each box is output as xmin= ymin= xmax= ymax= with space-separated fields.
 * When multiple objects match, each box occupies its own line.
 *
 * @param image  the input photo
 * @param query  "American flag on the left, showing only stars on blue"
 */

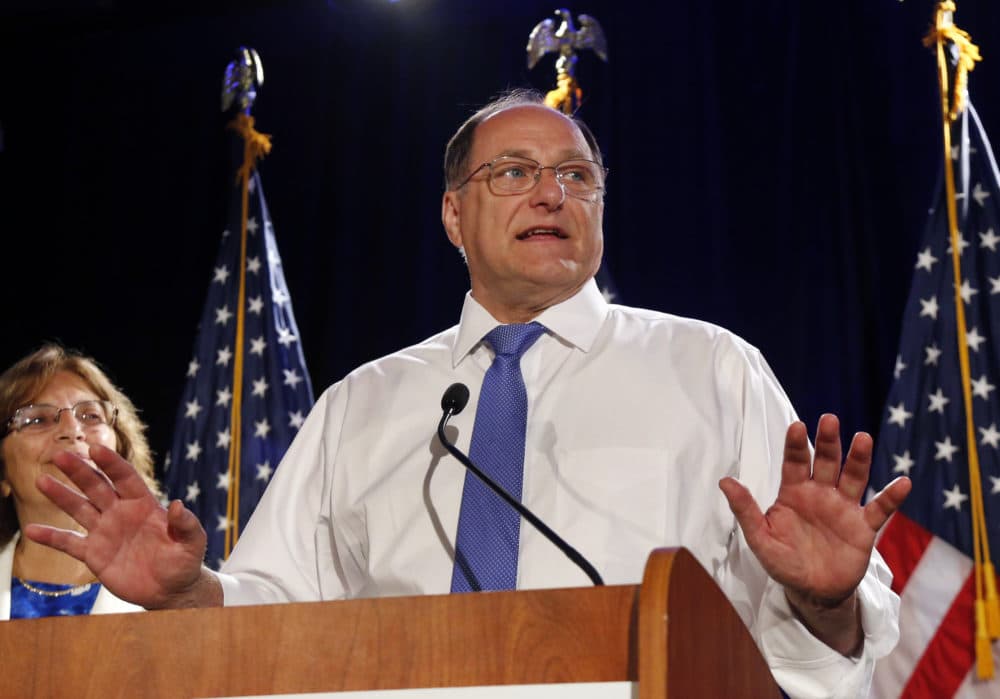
xmin=165 ymin=126 xmax=313 ymax=568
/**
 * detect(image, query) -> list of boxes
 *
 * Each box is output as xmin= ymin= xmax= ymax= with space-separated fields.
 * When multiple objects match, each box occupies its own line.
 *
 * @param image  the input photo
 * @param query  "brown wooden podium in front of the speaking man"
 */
xmin=0 ymin=549 xmax=779 ymax=699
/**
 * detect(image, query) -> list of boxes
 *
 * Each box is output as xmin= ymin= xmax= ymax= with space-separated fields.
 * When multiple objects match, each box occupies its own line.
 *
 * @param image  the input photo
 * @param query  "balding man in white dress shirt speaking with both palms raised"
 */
xmin=25 ymin=92 xmax=909 ymax=697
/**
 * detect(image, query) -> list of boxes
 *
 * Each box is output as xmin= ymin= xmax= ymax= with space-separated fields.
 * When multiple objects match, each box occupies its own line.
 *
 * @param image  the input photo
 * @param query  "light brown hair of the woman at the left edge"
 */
xmin=0 ymin=344 xmax=160 ymax=546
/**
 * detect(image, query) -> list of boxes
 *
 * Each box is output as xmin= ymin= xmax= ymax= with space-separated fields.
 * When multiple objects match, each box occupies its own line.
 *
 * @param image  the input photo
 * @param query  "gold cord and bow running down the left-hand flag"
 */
xmin=223 ymin=112 xmax=271 ymax=558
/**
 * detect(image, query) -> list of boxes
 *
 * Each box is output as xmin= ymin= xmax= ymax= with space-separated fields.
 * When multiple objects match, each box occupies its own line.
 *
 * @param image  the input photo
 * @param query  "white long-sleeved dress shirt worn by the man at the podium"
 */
xmin=220 ymin=281 xmax=898 ymax=698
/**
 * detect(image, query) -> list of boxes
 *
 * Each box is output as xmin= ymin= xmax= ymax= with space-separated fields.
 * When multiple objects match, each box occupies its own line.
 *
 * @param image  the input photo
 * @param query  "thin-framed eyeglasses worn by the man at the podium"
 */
xmin=455 ymin=155 xmax=608 ymax=201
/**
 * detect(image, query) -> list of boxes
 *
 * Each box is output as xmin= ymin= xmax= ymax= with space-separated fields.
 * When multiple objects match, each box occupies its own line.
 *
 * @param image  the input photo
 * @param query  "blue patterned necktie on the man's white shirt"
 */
xmin=451 ymin=323 xmax=545 ymax=592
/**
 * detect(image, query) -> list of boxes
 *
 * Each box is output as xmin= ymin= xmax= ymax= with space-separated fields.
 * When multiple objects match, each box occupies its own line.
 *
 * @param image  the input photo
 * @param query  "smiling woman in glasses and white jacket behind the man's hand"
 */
xmin=0 ymin=344 xmax=159 ymax=619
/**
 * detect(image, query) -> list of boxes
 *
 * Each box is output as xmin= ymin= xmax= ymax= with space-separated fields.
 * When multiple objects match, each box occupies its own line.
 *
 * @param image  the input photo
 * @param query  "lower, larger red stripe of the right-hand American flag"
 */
xmin=900 ymin=575 xmax=975 ymax=699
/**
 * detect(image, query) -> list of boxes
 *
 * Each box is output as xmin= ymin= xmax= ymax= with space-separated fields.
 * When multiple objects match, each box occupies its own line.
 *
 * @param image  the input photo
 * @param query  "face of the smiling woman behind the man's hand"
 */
xmin=0 ymin=371 xmax=117 ymax=520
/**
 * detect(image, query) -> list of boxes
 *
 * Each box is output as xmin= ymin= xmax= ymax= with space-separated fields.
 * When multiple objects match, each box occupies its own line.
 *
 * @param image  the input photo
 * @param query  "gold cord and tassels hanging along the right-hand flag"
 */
xmin=924 ymin=0 xmax=1000 ymax=679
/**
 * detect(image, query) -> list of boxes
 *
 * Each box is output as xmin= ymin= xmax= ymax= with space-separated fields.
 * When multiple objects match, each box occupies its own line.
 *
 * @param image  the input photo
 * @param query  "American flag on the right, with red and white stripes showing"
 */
xmin=871 ymin=95 xmax=1000 ymax=699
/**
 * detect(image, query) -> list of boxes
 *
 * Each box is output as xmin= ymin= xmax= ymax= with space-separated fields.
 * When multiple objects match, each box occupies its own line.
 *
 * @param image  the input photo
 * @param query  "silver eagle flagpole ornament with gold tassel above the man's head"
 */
xmin=527 ymin=8 xmax=608 ymax=114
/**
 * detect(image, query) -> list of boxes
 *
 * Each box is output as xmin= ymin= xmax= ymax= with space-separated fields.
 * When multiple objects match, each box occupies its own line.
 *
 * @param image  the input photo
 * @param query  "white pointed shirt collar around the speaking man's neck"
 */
xmin=451 ymin=279 xmax=608 ymax=366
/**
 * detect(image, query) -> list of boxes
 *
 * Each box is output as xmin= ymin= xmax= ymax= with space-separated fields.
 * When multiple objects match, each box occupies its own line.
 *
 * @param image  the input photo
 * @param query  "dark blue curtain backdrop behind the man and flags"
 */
xmin=0 ymin=0 xmax=1000 ymax=476
